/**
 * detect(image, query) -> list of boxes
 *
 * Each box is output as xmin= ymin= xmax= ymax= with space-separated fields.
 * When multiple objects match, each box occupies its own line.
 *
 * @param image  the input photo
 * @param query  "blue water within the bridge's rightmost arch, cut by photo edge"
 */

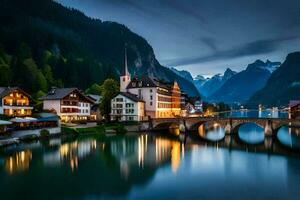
xmin=277 ymin=126 xmax=300 ymax=149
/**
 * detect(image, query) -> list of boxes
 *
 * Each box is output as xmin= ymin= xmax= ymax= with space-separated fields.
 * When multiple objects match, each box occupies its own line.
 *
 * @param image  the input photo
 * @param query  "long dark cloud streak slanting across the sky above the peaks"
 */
xmin=164 ymin=35 xmax=300 ymax=66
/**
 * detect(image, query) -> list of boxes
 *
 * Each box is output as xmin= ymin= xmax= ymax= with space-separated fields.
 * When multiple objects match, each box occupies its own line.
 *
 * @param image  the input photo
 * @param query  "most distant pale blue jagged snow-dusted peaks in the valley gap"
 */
xmin=194 ymin=68 xmax=236 ymax=97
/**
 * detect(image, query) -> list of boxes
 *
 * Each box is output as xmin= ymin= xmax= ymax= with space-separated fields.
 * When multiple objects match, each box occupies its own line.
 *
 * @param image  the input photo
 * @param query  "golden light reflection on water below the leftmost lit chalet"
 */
xmin=4 ymin=150 xmax=32 ymax=174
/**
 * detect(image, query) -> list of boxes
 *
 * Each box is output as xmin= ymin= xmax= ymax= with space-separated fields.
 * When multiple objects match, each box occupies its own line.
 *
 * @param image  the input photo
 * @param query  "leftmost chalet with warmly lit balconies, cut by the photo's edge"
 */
xmin=0 ymin=87 xmax=33 ymax=117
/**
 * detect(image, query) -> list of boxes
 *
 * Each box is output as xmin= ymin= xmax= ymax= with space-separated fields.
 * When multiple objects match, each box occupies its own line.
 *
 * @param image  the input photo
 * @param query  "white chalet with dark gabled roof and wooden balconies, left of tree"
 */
xmin=41 ymin=88 xmax=94 ymax=122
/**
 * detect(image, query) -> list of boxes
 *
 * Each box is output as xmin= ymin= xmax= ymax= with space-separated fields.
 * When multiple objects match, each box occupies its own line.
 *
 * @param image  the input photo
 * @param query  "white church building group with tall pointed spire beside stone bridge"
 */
xmin=111 ymin=51 xmax=181 ymax=121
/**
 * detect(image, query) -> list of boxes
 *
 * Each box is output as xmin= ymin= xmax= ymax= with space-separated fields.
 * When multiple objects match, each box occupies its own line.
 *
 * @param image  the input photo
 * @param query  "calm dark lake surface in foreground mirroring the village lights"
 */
xmin=0 ymin=129 xmax=300 ymax=200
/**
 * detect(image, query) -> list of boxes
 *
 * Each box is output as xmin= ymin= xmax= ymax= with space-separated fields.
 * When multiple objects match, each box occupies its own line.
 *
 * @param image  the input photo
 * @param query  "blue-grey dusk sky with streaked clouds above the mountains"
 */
xmin=58 ymin=0 xmax=300 ymax=76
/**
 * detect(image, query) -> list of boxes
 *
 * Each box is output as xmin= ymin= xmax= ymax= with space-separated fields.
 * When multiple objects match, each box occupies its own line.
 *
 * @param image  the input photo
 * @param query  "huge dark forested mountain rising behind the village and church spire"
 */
xmin=0 ymin=0 xmax=198 ymax=96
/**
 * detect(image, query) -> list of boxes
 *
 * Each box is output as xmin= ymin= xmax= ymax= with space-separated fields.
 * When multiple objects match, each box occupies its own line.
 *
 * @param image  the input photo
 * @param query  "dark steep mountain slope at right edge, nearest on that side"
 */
xmin=248 ymin=52 xmax=300 ymax=106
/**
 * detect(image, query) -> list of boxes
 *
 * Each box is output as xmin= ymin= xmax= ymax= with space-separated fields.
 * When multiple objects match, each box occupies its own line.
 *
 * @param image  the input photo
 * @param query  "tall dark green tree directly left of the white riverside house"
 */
xmin=100 ymin=79 xmax=119 ymax=120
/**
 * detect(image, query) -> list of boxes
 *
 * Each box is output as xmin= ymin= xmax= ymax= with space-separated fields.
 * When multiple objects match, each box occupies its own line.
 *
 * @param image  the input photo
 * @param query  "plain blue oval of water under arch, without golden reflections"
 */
xmin=238 ymin=123 xmax=265 ymax=144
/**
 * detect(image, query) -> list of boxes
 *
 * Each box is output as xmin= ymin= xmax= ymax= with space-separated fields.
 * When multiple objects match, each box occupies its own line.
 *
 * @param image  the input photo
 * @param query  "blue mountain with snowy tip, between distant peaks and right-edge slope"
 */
xmin=209 ymin=60 xmax=280 ymax=103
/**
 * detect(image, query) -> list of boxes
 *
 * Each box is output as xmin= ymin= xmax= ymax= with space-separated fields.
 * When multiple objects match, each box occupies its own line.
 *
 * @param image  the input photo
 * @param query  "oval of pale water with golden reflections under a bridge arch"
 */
xmin=198 ymin=123 xmax=225 ymax=141
